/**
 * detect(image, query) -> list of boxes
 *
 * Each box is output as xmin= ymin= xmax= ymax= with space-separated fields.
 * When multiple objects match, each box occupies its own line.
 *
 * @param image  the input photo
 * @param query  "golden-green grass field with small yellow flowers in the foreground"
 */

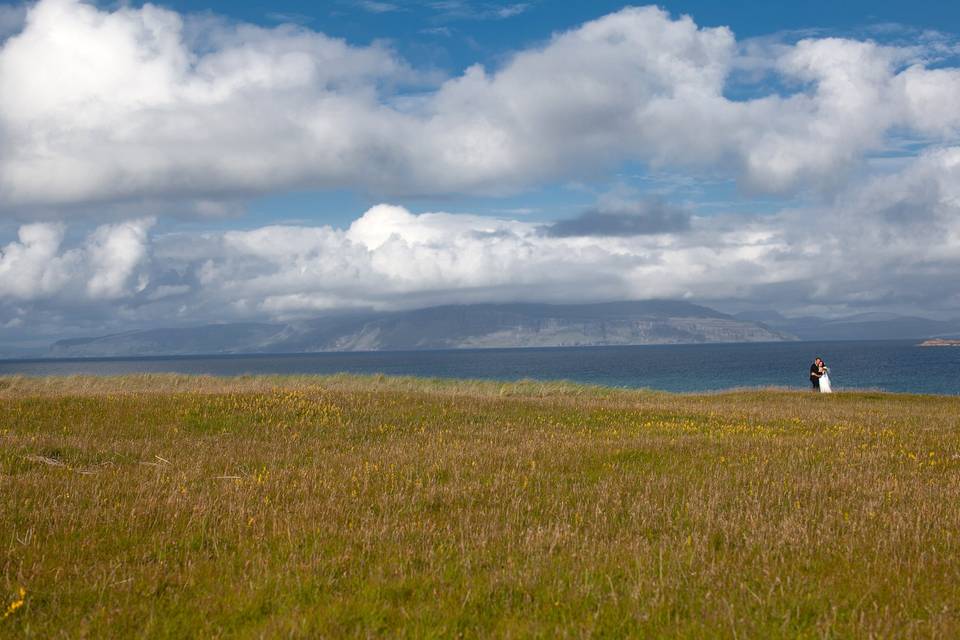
xmin=0 ymin=376 xmax=960 ymax=638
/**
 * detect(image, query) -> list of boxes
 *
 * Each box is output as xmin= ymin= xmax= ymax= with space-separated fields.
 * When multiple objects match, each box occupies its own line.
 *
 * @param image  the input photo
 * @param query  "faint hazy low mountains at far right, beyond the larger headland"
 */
xmin=735 ymin=311 xmax=960 ymax=340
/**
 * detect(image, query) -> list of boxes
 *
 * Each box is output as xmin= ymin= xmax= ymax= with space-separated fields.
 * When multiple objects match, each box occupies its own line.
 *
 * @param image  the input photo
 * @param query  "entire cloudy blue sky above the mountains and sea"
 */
xmin=0 ymin=0 xmax=960 ymax=346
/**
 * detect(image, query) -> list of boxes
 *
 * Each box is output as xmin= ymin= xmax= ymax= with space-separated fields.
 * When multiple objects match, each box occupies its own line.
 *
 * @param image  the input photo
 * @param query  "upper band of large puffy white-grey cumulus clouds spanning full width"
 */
xmin=0 ymin=0 xmax=960 ymax=215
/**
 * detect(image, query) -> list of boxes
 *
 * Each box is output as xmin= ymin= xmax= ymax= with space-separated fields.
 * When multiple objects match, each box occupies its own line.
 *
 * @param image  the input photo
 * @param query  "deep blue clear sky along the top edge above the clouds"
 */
xmin=134 ymin=0 xmax=960 ymax=82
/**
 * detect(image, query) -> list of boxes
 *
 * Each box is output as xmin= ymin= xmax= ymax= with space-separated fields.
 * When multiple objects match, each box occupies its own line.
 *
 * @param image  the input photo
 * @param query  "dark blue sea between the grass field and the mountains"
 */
xmin=0 ymin=340 xmax=960 ymax=395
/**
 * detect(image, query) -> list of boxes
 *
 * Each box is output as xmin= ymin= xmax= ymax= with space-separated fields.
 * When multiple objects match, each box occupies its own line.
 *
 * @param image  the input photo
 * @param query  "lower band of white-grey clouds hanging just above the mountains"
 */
xmin=0 ymin=148 xmax=960 ymax=336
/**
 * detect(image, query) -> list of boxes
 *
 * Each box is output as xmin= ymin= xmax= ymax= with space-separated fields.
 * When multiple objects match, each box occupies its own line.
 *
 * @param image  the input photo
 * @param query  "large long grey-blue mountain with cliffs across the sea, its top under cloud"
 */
xmin=48 ymin=300 xmax=796 ymax=357
